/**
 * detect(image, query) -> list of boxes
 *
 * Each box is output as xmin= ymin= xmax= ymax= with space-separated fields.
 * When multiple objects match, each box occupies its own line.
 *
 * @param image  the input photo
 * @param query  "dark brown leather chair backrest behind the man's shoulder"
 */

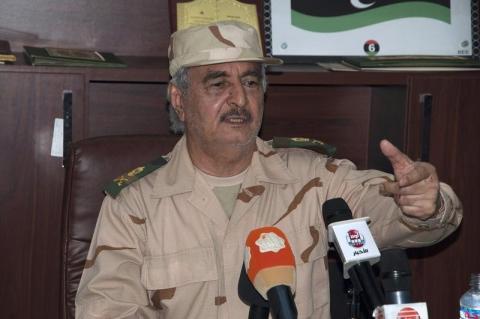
xmin=60 ymin=135 xmax=179 ymax=319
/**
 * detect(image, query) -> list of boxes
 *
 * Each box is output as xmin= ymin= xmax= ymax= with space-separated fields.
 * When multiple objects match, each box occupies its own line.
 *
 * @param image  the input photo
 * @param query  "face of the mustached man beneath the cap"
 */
xmin=173 ymin=62 xmax=264 ymax=147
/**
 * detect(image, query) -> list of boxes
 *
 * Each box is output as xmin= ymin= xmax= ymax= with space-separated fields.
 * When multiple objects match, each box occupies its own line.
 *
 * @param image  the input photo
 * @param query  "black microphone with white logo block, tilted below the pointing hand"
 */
xmin=322 ymin=198 xmax=384 ymax=314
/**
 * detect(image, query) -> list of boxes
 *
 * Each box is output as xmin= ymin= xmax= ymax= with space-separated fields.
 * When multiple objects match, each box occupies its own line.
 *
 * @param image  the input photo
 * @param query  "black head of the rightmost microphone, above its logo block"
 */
xmin=380 ymin=248 xmax=412 ymax=304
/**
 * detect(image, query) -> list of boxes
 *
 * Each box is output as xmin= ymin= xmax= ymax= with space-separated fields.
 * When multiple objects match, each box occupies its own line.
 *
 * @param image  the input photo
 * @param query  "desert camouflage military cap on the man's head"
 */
xmin=168 ymin=21 xmax=282 ymax=76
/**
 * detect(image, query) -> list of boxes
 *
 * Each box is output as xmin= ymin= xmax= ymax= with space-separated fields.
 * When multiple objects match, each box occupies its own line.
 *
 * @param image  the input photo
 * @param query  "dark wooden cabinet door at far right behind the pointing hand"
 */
xmin=408 ymin=76 xmax=480 ymax=318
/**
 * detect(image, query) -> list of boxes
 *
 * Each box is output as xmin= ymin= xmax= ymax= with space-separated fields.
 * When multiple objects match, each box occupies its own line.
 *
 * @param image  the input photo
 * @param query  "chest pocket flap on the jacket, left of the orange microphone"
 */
xmin=142 ymin=247 xmax=217 ymax=290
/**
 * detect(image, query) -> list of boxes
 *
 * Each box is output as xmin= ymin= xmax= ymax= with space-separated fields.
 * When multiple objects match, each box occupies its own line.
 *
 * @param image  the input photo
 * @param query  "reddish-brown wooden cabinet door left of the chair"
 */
xmin=0 ymin=72 xmax=83 ymax=319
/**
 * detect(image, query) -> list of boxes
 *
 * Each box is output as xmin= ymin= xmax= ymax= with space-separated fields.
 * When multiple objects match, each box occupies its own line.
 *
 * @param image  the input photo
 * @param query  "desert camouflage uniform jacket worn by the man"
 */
xmin=76 ymin=137 xmax=462 ymax=319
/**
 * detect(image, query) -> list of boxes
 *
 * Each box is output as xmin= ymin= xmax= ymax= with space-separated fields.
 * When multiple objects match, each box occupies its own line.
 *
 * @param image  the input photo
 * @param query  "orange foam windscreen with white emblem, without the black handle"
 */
xmin=244 ymin=227 xmax=295 ymax=299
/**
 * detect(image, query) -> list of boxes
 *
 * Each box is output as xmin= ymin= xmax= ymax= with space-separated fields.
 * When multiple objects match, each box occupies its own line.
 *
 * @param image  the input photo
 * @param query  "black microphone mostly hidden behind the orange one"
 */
xmin=238 ymin=264 xmax=270 ymax=319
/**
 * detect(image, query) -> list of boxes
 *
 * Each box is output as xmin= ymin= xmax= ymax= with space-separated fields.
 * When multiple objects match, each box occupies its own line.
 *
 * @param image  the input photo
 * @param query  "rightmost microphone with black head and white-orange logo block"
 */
xmin=375 ymin=248 xmax=428 ymax=319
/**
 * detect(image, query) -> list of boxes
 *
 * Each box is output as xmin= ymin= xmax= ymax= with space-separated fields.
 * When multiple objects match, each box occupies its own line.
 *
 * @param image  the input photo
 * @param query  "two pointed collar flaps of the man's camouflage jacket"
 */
xmin=153 ymin=136 xmax=298 ymax=198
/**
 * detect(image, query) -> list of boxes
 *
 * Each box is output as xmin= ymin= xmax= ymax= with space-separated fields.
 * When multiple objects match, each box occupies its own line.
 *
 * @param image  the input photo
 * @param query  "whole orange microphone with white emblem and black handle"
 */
xmin=244 ymin=227 xmax=297 ymax=319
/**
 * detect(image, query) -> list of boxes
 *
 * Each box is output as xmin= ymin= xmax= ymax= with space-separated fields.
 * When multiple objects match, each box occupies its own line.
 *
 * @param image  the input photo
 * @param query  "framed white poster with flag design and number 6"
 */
xmin=265 ymin=0 xmax=472 ymax=56
